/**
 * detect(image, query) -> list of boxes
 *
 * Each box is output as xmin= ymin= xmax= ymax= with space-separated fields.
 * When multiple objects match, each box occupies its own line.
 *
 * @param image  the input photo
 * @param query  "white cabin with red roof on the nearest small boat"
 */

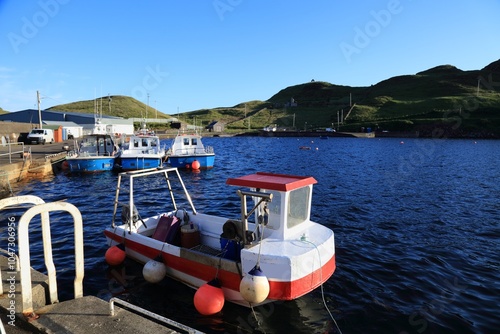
xmin=226 ymin=172 xmax=317 ymax=243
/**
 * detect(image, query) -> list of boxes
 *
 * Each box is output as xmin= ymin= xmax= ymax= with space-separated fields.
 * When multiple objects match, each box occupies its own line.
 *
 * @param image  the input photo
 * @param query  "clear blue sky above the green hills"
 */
xmin=0 ymin=0 xmax=500 ymax=114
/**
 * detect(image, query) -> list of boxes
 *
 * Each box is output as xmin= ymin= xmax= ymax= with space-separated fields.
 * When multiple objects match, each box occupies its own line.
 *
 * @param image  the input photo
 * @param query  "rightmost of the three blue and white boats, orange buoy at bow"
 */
xmin=167 ymin=133 xmax=215 ymax=169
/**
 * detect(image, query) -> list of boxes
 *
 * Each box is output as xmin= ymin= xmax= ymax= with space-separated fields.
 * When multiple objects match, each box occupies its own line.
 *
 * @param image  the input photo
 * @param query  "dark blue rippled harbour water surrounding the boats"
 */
xmin=0 ymin=137 xmax=500 ymax=333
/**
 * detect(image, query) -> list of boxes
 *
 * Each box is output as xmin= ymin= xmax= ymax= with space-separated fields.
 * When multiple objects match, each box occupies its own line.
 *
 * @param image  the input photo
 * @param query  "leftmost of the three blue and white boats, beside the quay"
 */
xmin=63 ymin=134 xmax=118 ymax=173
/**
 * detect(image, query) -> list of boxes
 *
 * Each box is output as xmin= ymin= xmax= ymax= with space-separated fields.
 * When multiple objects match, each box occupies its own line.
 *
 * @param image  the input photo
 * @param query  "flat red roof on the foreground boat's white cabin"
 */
xmin=226 ymin=172 xmax=318 ymax=191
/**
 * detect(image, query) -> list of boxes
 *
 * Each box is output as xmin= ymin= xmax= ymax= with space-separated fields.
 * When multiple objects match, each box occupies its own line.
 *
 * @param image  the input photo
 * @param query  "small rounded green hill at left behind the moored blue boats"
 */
xmin=49 ymin=95 xmax=170 ymax=118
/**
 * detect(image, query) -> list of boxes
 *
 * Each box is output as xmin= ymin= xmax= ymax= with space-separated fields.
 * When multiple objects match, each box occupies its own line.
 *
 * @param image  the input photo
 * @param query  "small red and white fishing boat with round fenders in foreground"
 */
xmin=104 ymin=168 xmax=335 ymax=314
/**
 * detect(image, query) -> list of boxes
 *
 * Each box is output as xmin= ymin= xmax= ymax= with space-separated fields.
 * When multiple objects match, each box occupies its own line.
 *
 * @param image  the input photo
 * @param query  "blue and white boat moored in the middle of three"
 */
xmin=115 ymin=134 xmax=166 ymax=170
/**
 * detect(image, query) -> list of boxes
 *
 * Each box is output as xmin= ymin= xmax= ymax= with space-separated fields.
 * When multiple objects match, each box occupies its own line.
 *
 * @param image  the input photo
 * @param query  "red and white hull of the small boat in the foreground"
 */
xmin=104 ymin=214 xmax=336 ymax=307
